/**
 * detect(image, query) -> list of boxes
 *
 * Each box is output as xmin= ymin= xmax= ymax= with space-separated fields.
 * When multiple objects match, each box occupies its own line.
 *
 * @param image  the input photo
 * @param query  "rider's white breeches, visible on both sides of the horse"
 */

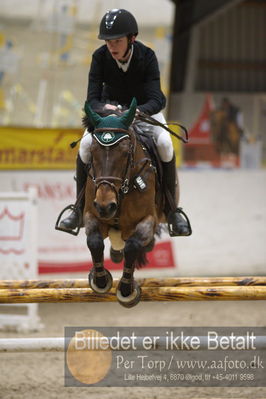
xmin=79 ymin=112 xmax=174 ymax=164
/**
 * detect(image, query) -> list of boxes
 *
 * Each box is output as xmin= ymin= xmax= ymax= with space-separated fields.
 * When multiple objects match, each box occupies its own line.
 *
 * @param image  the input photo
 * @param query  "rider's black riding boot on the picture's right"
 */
xmin=162 ymin=154 xmax=192 ymax=237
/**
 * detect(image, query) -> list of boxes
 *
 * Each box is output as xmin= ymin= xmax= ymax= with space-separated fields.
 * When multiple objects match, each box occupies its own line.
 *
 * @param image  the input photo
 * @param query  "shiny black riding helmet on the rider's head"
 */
xmin=98 ymin=8 xmax=138 ymax=40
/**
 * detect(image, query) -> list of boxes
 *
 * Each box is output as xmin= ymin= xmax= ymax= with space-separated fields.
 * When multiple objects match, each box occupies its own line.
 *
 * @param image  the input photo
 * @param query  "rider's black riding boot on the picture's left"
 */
xmin=60 ymin=154 xmax=87 ymax=230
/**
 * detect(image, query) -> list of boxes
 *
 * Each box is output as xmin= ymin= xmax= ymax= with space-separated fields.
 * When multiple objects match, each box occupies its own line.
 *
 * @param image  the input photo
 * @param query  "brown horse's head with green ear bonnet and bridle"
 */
xmin=85 ymin=99 xmax=137 ymax=219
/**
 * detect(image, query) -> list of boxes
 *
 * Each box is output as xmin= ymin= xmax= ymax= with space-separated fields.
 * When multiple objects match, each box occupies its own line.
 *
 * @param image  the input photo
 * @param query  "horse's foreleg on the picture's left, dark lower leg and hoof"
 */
xmin=87 ymin=225 xmax=113 ymax=294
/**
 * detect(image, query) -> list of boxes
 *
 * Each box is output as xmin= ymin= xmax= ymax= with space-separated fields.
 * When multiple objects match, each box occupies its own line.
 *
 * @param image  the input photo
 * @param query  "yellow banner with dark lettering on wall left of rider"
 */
xmin=0 ymin=127 xmax=83 ymax=170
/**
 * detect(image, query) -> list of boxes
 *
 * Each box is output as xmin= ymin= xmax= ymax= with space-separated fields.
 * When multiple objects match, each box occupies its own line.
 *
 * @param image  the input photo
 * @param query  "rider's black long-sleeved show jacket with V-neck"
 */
xmin=87 ymin=41 xmax=166 ymax=115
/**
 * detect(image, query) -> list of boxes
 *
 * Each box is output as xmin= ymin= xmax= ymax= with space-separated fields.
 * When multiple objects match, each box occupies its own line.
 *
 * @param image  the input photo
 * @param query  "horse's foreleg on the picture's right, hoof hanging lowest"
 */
xmin=117 ymin=216 xmax=155 ymax=307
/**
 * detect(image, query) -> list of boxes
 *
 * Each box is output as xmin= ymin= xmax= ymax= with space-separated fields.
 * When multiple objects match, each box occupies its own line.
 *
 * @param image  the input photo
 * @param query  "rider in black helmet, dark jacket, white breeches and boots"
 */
xmin=60 ymin=9 xmax=191 ymax=236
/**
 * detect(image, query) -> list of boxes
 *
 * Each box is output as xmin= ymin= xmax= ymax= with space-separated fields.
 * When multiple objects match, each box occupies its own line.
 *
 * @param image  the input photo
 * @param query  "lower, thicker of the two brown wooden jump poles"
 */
xmin=0 ymin=286 xmax=266 ymax=303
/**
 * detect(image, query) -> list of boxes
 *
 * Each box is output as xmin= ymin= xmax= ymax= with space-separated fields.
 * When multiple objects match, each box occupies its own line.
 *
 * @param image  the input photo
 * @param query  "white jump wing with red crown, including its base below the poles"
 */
xmin=0 ymin=187 xmax=41 ymax=331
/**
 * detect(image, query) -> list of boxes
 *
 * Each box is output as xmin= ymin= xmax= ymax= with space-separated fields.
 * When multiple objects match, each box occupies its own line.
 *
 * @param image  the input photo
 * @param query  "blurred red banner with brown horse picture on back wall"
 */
xmin=184 ymin=94 xmax=245 ymax=168
